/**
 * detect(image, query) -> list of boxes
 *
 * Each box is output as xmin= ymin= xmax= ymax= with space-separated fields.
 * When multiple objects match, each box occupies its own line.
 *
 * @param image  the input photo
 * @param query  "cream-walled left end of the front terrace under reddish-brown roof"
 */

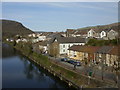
xmin=68 ymin=45 xmax=100 ymax=62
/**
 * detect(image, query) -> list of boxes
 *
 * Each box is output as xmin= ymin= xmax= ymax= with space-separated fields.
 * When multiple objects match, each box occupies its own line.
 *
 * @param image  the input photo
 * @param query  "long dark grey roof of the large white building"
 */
xmin=49 ymin=37 xmax=86 ymax=43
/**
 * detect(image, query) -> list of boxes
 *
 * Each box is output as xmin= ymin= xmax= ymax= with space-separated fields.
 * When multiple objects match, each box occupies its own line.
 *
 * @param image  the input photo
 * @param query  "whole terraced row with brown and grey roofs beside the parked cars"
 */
xmin=68 ymin=45 xmax=119 ymax=66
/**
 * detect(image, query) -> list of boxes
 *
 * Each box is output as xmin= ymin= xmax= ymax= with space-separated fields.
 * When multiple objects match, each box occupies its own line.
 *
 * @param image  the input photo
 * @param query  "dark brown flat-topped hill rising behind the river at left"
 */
xmin=0 ymin=20 xmax=33 ymax=37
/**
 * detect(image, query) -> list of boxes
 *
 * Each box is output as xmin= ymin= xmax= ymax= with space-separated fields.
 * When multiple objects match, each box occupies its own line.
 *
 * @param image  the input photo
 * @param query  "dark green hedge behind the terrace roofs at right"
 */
xmin=86 ymin=39 xmax=118 ymax=46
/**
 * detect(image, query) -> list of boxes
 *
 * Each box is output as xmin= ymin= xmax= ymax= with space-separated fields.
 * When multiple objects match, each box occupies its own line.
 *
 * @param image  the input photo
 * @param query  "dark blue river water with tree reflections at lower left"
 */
xmin=2 ymin=44 xmax=73 ymax=90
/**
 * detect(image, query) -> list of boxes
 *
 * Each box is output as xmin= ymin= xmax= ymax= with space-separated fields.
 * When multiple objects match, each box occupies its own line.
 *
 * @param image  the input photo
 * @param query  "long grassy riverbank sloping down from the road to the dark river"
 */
xmin=4 ymin=43 xmax=117 ymax=88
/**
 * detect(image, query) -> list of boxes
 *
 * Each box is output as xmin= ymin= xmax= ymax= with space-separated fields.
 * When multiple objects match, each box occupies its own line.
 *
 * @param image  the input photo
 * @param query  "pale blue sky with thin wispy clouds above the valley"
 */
xmin=2 ymin=0 xmax=118 ymax=32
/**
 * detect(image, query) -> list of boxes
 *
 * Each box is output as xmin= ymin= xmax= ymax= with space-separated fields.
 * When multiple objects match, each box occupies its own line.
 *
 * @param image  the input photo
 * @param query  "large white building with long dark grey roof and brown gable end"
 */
xmin=48 ymin=37 xmax=86 ymax=56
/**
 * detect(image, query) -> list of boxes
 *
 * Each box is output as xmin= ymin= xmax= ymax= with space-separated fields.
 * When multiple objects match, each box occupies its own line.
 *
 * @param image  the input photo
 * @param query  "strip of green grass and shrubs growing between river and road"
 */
xmin=7 ymin=42 xmax=116 ymax=88
